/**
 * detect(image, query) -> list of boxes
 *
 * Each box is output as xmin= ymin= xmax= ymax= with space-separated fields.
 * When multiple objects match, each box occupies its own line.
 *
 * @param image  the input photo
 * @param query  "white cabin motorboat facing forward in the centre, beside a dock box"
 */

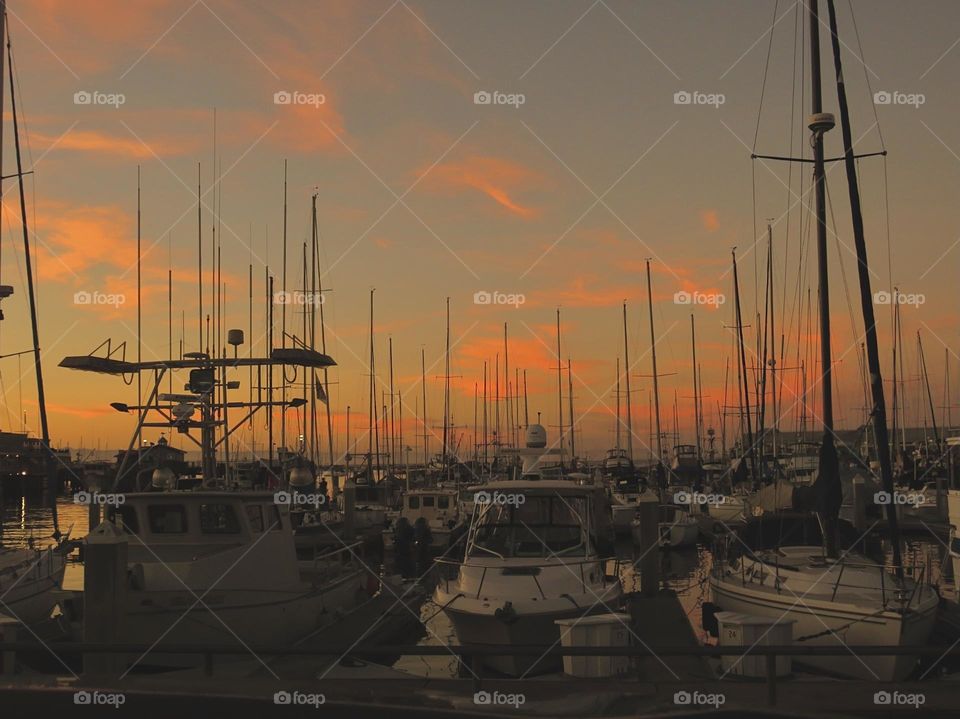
xmin=434 ymin=480 xmax=621 ymax=676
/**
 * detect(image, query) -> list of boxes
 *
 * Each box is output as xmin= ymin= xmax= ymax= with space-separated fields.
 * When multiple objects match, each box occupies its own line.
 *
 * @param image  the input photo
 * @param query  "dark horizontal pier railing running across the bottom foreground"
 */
xmin=0 ymin=640 xmax=960 ymax=706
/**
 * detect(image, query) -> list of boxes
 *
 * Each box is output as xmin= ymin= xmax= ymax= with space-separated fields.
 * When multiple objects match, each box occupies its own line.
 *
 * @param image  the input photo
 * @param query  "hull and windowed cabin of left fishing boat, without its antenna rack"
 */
xmin=94 ymin=490 xmax=365 ymax=664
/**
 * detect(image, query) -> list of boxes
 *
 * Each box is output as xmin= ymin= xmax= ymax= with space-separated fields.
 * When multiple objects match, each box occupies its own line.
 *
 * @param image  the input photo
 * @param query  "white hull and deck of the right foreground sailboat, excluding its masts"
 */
xmin=710 ymin=547 xmax=940 ymax=682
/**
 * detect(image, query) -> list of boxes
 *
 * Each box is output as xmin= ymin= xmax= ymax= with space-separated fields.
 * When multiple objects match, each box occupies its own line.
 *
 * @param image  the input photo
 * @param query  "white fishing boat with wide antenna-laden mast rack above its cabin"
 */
xmin=54 ymin=340 xmax=375 ymax=666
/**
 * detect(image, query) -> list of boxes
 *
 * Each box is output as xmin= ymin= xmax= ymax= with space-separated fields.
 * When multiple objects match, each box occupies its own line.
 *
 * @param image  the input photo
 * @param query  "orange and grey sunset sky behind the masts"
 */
xmin=0 ymin=0 xmax=960 ymax=458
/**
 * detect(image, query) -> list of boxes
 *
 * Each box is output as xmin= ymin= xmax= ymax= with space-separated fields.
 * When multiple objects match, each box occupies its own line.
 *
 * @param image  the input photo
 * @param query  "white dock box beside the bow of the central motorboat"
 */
xmin=556 ymin=614 xmax=632 ymax=678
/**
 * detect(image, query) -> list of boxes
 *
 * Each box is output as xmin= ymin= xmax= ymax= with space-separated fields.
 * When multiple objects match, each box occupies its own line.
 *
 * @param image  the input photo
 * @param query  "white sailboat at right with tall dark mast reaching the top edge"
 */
xmin=710 ymin=0 xmax=939 ymax=681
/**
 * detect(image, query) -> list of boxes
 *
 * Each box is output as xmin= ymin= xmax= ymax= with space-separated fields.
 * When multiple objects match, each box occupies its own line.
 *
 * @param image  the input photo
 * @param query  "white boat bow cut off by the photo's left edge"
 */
xmin=0 ymin=547 xmax=66 ymax=625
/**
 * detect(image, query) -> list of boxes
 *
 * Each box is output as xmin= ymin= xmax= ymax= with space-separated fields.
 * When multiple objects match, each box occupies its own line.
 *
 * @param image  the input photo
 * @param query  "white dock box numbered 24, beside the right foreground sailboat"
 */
xmin=717 ymin=612 xmax=794 ymax=679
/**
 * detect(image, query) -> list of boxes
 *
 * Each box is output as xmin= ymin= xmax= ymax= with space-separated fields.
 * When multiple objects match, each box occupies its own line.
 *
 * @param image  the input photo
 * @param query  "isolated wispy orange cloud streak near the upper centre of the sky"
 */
xmin=419 ymin=155 xmax=542 ymax=219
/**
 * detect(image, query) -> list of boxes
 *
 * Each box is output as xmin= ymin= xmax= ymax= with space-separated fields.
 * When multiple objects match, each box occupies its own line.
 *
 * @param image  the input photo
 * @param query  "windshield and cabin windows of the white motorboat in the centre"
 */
xmin=468 ymin=496 xmax=587 ymax=558
